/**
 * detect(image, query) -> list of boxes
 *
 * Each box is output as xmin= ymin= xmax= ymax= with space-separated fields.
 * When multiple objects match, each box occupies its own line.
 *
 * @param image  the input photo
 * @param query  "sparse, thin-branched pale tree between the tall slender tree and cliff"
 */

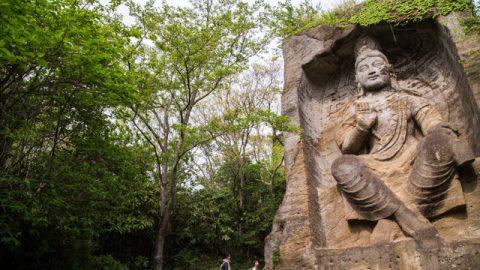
xmin=195 ymin=60 xmax=291 ymax=210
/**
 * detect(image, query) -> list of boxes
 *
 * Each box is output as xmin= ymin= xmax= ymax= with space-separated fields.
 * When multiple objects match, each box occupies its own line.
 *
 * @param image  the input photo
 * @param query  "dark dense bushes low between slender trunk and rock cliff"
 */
xmin=167 ymin=154 xmax=285 ymax=270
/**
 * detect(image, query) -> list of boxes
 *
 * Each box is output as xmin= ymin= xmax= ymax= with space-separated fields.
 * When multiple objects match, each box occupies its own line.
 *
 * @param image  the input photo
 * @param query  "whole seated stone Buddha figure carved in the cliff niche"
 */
xmin=331 ymin=37 xmax=474 ymax=243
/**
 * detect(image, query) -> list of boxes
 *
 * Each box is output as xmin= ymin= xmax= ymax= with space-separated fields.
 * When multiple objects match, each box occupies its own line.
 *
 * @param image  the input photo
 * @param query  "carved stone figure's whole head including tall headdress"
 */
xmin=355 ymin=37 xmax=391 ymax=91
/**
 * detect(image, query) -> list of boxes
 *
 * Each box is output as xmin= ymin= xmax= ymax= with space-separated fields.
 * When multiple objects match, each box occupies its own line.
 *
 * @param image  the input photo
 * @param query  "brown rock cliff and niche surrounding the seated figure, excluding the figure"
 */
xmin=265 ymin=13 xmax=480 ymax=269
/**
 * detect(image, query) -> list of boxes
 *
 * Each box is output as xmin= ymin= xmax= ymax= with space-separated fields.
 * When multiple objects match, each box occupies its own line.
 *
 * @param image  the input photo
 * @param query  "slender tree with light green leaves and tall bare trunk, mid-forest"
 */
xmin=122 ymin=0 xmax=264 ymax=270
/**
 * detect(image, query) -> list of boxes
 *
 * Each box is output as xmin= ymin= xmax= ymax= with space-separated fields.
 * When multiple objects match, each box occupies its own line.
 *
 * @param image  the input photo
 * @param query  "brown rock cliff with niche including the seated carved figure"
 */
xmin=265 ymin=14 xmax=480 ymax=270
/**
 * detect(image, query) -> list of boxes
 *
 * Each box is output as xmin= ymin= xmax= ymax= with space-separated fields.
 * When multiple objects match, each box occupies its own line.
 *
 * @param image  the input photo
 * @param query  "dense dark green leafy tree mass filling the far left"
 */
xmin=0 ymin=0 xmax=153 ymax=269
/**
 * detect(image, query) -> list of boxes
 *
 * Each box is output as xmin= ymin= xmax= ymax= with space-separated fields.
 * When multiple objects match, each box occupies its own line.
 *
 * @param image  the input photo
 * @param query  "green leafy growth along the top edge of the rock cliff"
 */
xmin=270 ymin=0 xmax=472 ymax=37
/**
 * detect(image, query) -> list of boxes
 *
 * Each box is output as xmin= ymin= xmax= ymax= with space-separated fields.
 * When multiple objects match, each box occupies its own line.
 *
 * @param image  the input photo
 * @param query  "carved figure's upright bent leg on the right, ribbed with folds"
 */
xmin=407 ymin=128 xmax=456 ymax=216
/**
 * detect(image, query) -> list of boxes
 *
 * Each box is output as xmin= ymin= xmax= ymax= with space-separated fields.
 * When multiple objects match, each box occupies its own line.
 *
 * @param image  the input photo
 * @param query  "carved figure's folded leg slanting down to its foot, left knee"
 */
xmin=331 ymin=155 xmax=437 ymax=239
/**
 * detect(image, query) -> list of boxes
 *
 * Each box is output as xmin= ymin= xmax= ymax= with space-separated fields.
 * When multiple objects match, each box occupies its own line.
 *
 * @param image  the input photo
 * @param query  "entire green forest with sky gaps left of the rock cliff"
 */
xmin=0 ymin=0 xmax=295 ymax=269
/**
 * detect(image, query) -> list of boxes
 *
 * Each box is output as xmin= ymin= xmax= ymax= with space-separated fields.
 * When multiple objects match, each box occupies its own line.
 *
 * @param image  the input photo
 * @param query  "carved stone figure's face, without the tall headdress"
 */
xmin=356 ymin=56 xmax=390 ymax=91
